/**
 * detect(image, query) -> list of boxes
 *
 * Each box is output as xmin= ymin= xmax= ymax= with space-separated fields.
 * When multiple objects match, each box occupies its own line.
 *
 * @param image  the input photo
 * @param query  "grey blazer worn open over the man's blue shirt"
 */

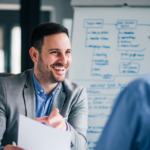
xmin=0 ymin=70 xmax=88 ymax=150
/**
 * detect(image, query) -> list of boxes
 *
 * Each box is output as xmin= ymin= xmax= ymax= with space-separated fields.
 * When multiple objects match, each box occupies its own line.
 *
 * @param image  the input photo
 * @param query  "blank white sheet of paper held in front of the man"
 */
xmin=18 ymin=115 xmax=71 ymax=150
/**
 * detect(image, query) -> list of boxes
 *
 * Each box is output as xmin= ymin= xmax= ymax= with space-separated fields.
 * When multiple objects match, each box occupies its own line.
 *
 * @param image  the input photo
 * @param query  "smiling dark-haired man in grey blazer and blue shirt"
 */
xmin=0 ymin=23 xmax=88 ymax=150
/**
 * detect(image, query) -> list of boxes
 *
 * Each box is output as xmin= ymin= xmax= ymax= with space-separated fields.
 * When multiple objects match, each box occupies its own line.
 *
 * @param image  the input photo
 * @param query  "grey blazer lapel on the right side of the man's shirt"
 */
xmin=50 ymin=83 xmax=66 ymax=114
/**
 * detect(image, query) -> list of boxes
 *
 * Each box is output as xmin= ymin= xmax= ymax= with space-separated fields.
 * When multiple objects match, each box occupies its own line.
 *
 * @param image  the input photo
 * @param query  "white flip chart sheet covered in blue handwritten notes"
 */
xmin=69 ymin=7 xmax=150 ymax=150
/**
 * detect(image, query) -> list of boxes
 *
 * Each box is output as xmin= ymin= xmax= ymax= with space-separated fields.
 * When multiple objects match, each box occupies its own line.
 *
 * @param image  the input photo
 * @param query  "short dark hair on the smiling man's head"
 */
xmin=31 ymin=22 xmax=69 ymax=53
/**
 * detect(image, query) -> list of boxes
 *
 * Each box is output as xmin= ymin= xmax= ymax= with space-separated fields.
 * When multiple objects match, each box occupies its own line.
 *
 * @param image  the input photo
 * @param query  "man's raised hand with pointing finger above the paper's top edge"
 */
xmin=35 ymin=108 xmax=67 ymax=130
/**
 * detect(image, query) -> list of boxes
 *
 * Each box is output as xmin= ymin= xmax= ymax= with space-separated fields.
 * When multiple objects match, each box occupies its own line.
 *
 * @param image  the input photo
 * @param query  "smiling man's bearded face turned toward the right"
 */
xmin=37 ymin=33 xmax=72 ymax=83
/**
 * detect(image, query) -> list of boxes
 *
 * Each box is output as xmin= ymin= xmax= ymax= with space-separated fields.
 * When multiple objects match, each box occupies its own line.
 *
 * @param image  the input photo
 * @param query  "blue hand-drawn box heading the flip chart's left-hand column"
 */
xmin=83 ymin=19 xmax=103 ymax=28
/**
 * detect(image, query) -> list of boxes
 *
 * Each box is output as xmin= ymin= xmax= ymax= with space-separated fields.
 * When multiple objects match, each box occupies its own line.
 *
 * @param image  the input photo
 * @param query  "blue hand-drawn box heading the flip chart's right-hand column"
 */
xmin=117 ymin=20 xmax=137 ymax=29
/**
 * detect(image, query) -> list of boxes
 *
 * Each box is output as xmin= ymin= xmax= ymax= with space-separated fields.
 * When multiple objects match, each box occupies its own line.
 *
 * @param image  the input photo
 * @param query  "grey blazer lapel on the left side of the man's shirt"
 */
xmin=24 ymin=70 xmax=35 ymax=119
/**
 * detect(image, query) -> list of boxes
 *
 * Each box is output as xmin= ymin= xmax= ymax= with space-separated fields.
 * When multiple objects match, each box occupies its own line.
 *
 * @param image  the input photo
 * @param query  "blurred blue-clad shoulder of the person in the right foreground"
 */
xmin=95 ymin=75 xmax=150 ymax=150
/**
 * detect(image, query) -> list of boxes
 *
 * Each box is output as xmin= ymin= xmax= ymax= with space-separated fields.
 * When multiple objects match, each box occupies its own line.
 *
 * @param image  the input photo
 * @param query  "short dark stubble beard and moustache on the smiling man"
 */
xmin=37 ymin=55 xmax=65 ymax=83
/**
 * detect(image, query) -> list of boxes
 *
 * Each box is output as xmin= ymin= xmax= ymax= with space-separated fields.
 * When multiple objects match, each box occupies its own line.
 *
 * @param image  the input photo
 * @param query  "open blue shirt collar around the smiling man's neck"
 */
xmin=33 ymin=71 xmax=61 ymax=95
